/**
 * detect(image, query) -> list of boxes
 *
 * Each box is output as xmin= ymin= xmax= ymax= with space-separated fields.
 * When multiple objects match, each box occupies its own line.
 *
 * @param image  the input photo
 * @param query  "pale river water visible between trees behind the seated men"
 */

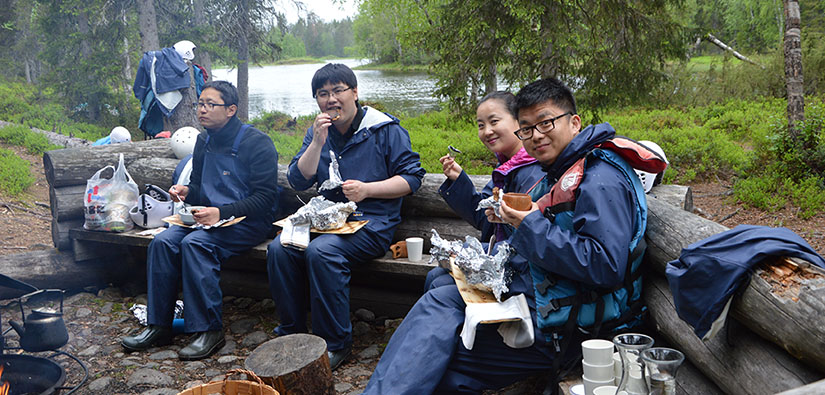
xmin=212 ymin=59 xmax=439 ymax=118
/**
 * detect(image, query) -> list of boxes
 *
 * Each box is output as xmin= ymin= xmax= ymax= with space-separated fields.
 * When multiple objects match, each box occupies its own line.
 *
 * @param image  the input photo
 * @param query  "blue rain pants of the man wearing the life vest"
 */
xmin=363 ymin=285 xmax=575 ymax=395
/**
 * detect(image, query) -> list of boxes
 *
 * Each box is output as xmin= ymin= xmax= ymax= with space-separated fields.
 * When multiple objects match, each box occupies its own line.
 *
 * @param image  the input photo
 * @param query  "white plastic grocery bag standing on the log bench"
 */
xmin=83 ymin=154 xmax=138 ymax=232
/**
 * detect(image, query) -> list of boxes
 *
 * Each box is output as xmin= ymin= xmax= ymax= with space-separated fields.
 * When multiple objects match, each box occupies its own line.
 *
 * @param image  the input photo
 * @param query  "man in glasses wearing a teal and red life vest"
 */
xmin=364 ymin=78 xmax=647 ymax=395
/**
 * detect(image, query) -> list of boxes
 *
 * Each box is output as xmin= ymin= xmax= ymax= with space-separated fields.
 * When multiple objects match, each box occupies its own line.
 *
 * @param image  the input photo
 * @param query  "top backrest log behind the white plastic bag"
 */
xmin=43 ymin=139 xmax=175 ymax=187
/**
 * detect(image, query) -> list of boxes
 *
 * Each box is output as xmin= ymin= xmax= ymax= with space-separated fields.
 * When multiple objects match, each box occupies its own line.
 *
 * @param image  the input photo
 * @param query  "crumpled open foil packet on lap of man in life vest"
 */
xmin=430 ymin=229 xmax=512 ymax=302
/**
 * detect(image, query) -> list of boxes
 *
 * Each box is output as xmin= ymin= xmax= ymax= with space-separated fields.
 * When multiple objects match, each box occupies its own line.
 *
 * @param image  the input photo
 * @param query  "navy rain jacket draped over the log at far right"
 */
xmin=666 ymin=225 xmax=825 ymax=338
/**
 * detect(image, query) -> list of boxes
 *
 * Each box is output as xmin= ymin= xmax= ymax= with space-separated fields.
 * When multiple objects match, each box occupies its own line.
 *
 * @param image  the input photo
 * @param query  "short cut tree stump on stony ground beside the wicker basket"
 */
xmin=244 ymin=333 xmax=335 ymax=395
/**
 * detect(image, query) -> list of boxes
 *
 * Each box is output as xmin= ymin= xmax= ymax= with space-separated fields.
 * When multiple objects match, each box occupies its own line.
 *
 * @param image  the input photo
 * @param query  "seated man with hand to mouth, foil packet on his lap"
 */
xmin=267 ymin=63 xmax=424 ymax=369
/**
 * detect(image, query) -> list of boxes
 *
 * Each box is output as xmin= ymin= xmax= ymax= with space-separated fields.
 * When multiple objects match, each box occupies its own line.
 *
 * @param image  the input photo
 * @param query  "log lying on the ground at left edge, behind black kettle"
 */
xmin=0 ymin=249 xmax=146 ymax=299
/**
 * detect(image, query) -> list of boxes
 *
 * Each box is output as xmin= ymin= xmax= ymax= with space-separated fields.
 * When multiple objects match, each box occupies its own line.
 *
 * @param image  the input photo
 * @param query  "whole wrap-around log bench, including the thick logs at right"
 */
xmin=44 ymin=140 xmax=825 ymax=393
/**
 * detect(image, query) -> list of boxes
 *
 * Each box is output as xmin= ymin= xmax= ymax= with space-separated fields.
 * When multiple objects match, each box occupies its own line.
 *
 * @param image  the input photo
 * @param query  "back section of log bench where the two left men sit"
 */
xmin=43 ymin=140 xmax=482 ymax=316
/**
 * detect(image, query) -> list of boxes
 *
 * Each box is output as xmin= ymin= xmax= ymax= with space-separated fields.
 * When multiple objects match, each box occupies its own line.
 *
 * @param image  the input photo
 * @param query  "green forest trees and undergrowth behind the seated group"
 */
xmin=0 ymin=0 xmax=825 ymax=219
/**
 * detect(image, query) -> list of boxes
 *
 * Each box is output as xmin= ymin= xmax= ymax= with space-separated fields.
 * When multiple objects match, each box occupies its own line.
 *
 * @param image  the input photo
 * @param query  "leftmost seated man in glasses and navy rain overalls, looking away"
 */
xmin=121 ymin=81 xmax=278 ymax=360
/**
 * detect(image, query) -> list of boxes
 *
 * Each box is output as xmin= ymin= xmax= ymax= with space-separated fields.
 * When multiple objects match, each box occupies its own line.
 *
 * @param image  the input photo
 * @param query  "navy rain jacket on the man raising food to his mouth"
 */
xmin=287 ymin=107 xmax=425 ymax=242
